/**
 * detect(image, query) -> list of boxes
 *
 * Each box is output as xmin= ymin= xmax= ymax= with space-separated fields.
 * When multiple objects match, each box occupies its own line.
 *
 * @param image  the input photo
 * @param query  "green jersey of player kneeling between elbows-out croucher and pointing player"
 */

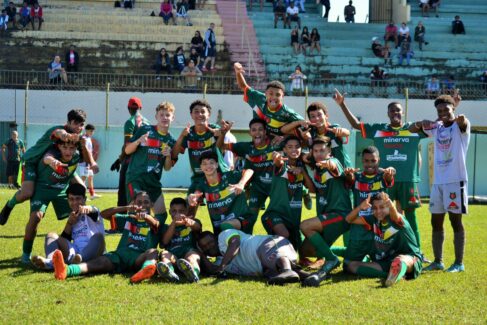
xmin=313 ymin=158 xmax=352 ymax=216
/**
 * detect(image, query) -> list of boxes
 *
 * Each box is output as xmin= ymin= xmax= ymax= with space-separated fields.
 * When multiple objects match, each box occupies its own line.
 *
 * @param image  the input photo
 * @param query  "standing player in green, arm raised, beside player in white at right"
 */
xmin=333 ymin=91 xmax=426 ymax=253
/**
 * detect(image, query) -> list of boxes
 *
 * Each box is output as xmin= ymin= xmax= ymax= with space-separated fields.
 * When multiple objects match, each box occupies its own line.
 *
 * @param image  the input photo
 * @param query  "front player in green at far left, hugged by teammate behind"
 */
xmin=21 ymin=141 xmax=82 ymax=264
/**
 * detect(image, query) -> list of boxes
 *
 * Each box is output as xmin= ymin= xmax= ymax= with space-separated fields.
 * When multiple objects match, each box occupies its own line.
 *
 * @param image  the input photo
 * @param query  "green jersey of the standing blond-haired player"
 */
xmin=127 ymin=125 xmax=176 ymax=181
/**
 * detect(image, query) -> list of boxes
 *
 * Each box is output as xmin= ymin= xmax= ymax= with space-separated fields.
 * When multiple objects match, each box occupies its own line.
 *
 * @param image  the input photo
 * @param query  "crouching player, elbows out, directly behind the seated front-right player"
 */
xmin=344 ymin=146 xmax=396 ymax=264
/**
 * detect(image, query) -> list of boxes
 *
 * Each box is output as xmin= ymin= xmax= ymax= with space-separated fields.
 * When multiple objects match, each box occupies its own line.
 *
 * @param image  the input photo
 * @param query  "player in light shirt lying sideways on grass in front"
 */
xmin=198 ymin=229 xmax=304 ymax=284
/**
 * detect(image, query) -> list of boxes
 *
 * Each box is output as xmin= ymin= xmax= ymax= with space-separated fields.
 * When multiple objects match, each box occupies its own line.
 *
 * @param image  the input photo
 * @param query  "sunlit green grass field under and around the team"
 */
xmin=0 ymin=189 xmax=487 ymax=324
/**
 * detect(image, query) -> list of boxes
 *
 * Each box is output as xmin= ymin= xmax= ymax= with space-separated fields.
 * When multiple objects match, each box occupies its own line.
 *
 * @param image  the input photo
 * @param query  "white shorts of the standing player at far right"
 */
xmin=430 ymin=181 xmax=468 ymax=214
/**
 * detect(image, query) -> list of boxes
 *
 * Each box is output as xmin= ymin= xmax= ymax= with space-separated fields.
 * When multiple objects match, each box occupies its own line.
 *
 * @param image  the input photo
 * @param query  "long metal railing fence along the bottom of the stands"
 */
xmin=0 ymin=70 xmax=487 ymax=100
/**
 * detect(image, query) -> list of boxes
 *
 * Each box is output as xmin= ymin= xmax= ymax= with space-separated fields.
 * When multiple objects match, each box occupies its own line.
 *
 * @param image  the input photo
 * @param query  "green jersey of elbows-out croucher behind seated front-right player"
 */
xmin=350 ymin=170 xmax=394 ymax=240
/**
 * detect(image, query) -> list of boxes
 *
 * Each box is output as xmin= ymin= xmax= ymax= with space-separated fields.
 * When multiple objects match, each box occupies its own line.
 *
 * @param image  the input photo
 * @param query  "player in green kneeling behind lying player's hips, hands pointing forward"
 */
xmin=261 ymin=136 xmax=312 ymax=250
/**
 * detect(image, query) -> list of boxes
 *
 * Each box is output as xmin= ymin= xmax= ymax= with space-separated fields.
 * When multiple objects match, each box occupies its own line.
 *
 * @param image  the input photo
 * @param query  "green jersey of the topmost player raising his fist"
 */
xmin=244 ymin=87 xmax=304 ymax=136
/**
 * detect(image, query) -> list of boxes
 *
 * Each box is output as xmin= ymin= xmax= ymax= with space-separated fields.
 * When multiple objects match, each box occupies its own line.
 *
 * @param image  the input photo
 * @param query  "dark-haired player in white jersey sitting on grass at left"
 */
xmin=31 ymin=183 xmax=105 ymax=270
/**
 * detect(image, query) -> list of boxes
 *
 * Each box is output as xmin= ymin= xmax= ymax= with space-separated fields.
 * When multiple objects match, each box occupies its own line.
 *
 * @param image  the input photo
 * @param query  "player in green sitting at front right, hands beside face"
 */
xmin=347 ymin=192 xmax=423 ymax=287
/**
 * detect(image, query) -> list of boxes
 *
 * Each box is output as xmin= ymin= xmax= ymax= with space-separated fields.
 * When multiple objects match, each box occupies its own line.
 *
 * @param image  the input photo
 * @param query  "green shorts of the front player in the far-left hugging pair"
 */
xmin=30 ymin=186 xmax=71 ymax=220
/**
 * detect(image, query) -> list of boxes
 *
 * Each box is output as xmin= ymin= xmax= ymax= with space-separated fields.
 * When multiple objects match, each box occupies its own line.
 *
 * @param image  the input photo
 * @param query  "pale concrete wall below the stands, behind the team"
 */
xmin=0 ymin=90 xmax=487 ymax=195
